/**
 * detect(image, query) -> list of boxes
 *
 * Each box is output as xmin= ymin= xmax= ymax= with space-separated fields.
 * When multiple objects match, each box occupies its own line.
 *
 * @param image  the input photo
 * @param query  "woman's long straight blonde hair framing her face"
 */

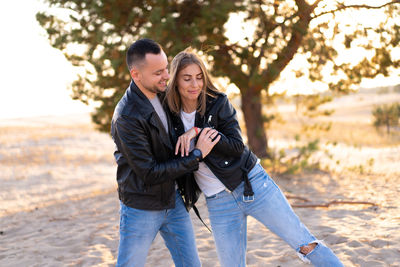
xmin=166 ymin=47 xmax=218 ymax=116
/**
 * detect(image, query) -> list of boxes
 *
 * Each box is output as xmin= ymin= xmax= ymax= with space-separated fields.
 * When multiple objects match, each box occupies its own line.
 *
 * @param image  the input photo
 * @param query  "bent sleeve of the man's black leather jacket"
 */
xmin=115 ymin=116 xmax=199 ymax=185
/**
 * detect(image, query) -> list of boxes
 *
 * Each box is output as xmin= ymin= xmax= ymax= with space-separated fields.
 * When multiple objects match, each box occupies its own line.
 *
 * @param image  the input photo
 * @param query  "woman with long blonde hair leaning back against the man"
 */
xmin=167 ymin=49 xmax=343 ymax=267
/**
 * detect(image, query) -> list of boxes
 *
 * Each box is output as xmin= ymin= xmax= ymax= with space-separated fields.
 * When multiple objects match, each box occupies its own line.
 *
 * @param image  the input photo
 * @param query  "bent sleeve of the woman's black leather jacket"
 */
xmin=210 ymin=96 xmax=245 ymax=157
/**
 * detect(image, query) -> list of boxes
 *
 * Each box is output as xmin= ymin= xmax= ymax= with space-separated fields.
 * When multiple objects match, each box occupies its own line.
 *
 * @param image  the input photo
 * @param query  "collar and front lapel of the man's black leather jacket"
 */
xmin=127 ymin=81 xmax=173 ymax=149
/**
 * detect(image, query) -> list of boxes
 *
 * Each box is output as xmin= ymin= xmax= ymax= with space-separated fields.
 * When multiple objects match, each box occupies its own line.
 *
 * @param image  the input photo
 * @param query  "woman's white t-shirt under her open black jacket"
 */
xmin=181 ymin=110 xmax=225 ymax=197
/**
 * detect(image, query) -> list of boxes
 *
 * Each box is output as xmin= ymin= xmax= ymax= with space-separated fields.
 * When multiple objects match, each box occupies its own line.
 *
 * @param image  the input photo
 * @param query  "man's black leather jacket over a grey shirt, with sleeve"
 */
xmin=111 ymin=81 xmax=199 ymax=210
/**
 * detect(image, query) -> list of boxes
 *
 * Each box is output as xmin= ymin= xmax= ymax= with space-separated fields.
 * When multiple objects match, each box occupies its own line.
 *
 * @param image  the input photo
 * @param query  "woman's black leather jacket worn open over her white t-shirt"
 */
xmin=170 ymin=93 xmax=257 ymax=209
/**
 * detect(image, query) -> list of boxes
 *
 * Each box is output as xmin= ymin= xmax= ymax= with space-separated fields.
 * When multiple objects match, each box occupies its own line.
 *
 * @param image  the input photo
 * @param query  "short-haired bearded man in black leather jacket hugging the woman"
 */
xmin=111 ymin=39 xmax=219 ymax=266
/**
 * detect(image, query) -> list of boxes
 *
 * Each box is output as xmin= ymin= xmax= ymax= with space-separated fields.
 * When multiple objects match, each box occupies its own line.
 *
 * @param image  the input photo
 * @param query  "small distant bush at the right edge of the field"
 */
xmin=372 ymin=103 xmax=400 ymax=134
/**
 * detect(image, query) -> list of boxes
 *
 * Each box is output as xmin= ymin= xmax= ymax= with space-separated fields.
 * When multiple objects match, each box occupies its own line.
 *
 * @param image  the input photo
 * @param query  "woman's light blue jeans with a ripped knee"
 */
xmin=206 ymin=164 xmax=343 ymax=267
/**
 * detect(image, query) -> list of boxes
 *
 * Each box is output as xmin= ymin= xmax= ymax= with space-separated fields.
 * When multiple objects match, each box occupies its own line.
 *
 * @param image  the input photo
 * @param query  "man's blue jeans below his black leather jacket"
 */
xmin=117 ymin=192 xmax=201 ymax=267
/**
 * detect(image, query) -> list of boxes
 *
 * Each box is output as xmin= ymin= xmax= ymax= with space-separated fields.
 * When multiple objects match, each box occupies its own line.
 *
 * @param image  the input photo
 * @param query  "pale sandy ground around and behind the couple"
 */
xmin=0 ymin=91 xmax=400 ymax=267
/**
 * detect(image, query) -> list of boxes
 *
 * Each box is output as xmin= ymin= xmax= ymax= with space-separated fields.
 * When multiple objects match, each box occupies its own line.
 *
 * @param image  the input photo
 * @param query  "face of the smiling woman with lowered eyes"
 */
xmin=177 ymin=63 xmax=204 ymax=103
